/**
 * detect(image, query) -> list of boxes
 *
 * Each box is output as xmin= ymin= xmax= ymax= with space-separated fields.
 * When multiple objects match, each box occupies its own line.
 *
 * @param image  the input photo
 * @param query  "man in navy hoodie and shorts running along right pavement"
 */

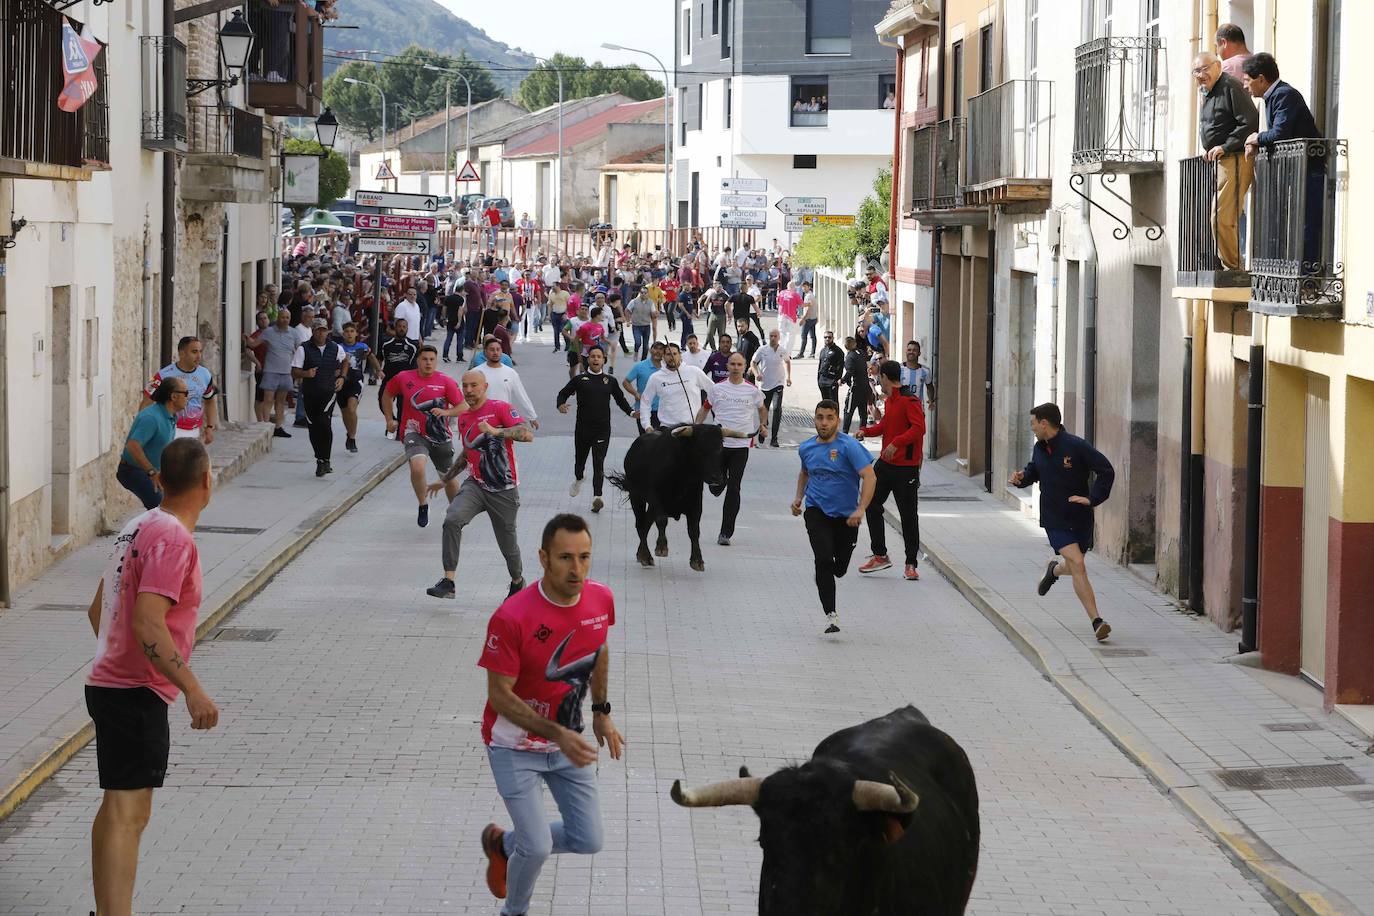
xmin=1009 ymin=404 xmax=1116 ymax=643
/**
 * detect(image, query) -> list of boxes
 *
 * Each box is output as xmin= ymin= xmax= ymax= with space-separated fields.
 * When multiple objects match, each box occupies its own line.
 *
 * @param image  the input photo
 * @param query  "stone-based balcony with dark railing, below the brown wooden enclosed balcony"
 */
xmin=181 ymin=106 xmax=272 ymax=203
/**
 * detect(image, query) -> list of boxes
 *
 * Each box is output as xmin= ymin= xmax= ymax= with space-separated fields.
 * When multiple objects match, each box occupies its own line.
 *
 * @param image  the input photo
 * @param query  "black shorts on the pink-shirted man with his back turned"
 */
xmin=85 ymin=684 xmax=172 ymax=790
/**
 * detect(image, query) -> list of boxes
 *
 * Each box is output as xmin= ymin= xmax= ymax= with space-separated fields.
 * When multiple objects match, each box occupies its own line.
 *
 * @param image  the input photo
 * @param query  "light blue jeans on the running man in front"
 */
xmin=486 ymin=747 xmax=602 ymax=916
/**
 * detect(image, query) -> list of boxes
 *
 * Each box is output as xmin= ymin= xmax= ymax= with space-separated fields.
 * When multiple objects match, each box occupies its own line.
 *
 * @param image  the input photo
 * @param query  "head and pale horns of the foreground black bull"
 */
xmin=672 ymin=759 xmax=934 ymax=916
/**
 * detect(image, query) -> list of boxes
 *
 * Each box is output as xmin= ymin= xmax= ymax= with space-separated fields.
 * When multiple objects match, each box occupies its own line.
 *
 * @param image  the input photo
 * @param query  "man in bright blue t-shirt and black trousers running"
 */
xmin=791 ymin=400 xmax=877 ymax=633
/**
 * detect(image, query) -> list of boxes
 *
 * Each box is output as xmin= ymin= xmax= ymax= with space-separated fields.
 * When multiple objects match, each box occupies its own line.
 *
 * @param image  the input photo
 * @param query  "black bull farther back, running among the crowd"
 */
xmin=607 ymin=423 xmax=749 ymax=573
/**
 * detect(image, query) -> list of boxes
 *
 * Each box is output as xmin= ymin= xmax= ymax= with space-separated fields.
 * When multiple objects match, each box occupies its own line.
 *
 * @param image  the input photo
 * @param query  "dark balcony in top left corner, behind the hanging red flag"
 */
xmin=0 ymin=0 xmax=110 ymax=181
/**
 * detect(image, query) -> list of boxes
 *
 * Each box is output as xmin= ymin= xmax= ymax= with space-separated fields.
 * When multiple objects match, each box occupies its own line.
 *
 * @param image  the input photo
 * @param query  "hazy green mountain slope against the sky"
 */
xmin=324 ymin=0 xmax=536 ymax=93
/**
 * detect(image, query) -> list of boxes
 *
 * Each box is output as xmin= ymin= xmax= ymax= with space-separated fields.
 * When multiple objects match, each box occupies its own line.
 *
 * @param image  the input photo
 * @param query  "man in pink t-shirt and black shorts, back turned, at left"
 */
xmin=85 ymin=438 xmax=220 ymax=913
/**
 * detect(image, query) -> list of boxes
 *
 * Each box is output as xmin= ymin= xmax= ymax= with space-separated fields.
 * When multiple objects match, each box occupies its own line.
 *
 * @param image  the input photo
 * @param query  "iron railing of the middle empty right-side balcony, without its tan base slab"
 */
xmin=967 ymin=80 xmax=1054 ymax=188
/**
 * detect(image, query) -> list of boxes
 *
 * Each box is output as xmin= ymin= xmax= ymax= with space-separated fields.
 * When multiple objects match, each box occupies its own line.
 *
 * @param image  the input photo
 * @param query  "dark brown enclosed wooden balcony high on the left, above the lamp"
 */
xmin=246 ymin=0 xmax=324 ymax=117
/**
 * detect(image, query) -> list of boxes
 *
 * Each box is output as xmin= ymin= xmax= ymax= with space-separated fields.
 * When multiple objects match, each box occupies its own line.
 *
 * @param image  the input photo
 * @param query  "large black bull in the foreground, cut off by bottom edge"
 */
xmin=672 ymin=706 xmax=978 ymax=916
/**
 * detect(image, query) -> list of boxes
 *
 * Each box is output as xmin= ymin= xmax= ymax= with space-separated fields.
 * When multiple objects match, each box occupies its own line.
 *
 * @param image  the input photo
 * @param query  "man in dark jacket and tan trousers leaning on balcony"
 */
xmin=1193 ymin=51 xmax=1260 ymax=271
